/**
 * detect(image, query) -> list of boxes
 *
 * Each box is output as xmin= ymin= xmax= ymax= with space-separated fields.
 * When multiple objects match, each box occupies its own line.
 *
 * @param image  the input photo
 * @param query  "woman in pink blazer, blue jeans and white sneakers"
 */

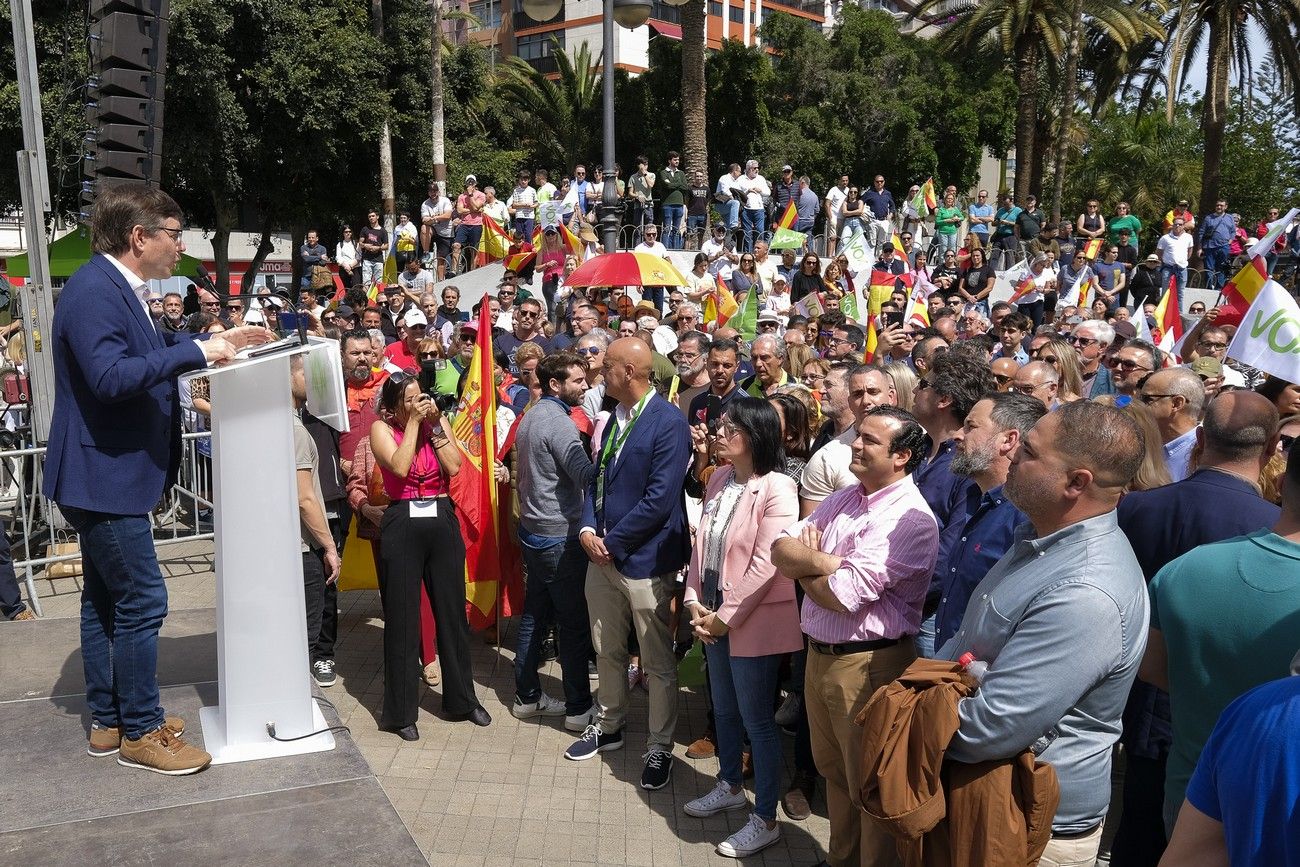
xmin=685 ymin=398 xmax=803 ymax=858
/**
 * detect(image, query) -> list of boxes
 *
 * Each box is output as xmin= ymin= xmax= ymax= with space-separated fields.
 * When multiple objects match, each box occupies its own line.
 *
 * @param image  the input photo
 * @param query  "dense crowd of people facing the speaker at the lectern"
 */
xmin=17 ymin=178 xmax=1300 ymax=867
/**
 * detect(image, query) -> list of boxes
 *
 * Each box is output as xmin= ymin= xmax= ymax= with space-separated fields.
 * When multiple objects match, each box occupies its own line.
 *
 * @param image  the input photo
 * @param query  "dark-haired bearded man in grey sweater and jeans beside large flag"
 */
xmin=511 ymin=352 xmax=595 ymax=732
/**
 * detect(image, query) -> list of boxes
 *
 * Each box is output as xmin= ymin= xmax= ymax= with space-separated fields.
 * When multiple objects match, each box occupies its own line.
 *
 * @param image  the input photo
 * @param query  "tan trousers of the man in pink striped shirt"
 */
xmin=800 ymin=638 xmax=917 ymax=867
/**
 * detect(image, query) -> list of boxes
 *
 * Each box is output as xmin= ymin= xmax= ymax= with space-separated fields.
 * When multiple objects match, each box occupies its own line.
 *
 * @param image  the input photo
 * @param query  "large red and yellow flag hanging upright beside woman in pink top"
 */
xmin=451 ymin=301 xmax=502 ymax=629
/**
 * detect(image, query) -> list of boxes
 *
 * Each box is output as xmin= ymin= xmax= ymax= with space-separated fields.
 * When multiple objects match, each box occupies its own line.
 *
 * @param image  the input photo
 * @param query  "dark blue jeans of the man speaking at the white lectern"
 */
xmin=60 ymin=506 xmax=166 ymax=741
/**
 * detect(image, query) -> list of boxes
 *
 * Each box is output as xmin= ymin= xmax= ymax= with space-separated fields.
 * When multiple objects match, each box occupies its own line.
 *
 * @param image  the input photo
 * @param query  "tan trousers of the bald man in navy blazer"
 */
xmin=586 ymin=563 xmax=677 ymax=753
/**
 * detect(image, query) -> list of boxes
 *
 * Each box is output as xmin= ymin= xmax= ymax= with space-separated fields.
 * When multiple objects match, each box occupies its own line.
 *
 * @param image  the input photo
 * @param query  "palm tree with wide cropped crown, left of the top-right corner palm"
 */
xmin=911 ymin=0 xmax=1164 ymax=201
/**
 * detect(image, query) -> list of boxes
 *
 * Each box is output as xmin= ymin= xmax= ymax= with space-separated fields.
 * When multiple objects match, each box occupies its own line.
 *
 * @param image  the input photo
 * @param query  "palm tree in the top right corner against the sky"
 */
xmin=1128 ymin=0 xmax=1300 ymax=213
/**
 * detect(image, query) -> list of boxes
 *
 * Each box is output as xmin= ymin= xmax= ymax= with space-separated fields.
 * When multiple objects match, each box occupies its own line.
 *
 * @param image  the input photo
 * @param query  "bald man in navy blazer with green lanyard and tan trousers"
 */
xmin=564 ymin=337 xmax=690 ymax=789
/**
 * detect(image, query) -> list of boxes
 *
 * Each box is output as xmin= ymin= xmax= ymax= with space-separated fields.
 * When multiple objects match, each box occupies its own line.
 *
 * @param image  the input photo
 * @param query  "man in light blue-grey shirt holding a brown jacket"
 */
xmin=937 ymin=400 xmax=1154 ymax=864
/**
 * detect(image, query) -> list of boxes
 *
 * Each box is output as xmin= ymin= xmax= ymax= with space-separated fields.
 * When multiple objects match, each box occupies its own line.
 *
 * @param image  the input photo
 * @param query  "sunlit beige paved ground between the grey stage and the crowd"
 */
xmin=27 ymin=542 xmax=829 ymax=867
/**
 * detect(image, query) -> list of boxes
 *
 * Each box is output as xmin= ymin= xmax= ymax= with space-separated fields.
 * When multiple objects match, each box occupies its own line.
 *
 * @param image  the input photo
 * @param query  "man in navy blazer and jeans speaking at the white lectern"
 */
xmin=44 ymin=186 xmax=272 ymax=776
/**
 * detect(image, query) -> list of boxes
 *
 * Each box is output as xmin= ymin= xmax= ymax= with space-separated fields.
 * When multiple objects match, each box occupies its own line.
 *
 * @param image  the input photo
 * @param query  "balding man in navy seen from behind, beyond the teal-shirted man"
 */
xmin=1112 ymin=391 xmax=1281 ymax=864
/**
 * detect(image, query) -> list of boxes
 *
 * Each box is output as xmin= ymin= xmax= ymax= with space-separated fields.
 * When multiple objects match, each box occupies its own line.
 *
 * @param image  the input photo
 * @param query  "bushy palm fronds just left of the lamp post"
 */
xmin=497 ymin=40 xmax=605 ymax=165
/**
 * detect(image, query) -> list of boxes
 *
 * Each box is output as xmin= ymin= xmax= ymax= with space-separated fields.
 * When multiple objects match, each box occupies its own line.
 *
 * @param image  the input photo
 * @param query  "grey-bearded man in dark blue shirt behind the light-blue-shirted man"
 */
xmin=935 ymin=391 xmax=1048 ymax=646
